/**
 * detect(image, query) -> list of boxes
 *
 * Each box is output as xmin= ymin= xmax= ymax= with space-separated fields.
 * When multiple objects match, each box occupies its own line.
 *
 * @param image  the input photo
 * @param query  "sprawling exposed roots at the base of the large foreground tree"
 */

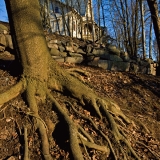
xmin=0 ymin=61 xmax=157 ymax=160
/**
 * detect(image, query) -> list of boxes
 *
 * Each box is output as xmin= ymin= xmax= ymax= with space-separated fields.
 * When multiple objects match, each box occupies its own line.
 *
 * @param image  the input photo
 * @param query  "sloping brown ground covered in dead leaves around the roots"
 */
xmin=0 ymin=57 xmax=160 ymax=160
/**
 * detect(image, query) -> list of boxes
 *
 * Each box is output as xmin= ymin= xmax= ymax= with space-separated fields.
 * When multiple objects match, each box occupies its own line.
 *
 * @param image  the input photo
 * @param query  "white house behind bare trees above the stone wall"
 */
xmin=40 ymin=0 xmax=99 ymax=41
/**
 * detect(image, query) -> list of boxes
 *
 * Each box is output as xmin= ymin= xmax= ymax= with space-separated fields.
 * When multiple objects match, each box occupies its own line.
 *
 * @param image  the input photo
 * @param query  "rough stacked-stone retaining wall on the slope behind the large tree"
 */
xmin=0 ymin=24 xmax=157 ymax=75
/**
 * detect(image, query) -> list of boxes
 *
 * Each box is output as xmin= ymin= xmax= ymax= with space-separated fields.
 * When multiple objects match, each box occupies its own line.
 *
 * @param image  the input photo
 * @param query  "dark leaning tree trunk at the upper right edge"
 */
xmin=147 ymin=0 xmax=160 ymax=75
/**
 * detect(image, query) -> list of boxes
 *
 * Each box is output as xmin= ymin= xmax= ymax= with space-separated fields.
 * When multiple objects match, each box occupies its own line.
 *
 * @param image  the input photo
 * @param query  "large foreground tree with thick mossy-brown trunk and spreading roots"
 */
xmin=0 ymin=0 xmax=152 ymax=160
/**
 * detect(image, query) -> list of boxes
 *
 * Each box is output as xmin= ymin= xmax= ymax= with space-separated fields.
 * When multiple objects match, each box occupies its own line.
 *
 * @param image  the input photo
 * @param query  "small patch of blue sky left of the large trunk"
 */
xmin=0 ymin=0 xmax=8 ymax=22
